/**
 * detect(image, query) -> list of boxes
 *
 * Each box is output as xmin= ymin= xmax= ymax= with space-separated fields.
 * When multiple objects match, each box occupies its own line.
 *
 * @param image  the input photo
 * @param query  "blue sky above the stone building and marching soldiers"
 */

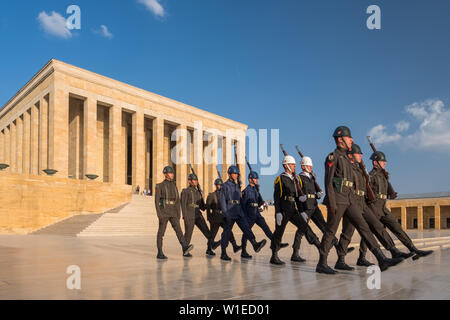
xmin=0 ymin=0 xmax=450 ymax=199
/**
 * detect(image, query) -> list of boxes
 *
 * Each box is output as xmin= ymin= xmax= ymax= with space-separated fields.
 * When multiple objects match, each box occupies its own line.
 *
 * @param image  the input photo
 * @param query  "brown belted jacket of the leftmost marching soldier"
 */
xmin=155 ymin=180 xmax=181 ymax=218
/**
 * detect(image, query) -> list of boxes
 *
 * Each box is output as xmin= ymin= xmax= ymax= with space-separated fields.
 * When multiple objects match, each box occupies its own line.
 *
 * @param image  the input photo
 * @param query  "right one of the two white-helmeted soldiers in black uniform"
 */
xmin=291 ymin=157 xmax=346 ymax=262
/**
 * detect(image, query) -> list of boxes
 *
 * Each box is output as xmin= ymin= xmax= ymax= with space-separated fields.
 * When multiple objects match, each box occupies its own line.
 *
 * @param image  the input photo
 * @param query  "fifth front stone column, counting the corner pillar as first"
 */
xmin=152 ymin=118 xmax=165 ymax=188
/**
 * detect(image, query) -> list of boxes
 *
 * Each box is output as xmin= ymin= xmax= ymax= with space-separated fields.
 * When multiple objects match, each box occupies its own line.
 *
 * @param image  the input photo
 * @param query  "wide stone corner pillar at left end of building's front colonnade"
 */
xmin=48 ymin=88 xmax=69 ymax=178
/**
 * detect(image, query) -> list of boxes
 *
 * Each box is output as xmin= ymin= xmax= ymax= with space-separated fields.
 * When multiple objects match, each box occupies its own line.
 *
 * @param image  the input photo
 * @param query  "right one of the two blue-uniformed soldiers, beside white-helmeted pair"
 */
xmin=241 ymin=171 xmax=288 ymax=259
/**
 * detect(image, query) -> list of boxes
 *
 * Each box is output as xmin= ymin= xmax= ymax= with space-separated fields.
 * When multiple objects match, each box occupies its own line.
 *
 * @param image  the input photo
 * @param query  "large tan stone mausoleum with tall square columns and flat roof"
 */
xmin=0 ymin=60 xmax=247 ymax=233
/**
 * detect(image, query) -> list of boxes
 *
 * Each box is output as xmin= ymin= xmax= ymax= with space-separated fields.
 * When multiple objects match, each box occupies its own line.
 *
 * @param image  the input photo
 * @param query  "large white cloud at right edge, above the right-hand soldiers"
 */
xmin=369 ymin=99 xmax=450 ymax=151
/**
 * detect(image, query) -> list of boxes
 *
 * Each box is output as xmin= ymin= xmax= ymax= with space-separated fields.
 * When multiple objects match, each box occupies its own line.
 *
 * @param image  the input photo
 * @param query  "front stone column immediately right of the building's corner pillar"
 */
xmin=82 ymin=97 xmax=99 ymax=179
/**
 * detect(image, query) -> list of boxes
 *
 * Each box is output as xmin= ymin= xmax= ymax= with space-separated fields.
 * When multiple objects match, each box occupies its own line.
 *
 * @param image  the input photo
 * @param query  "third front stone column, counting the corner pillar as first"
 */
xmin=109 ymin=106 xmax=125 ymax=184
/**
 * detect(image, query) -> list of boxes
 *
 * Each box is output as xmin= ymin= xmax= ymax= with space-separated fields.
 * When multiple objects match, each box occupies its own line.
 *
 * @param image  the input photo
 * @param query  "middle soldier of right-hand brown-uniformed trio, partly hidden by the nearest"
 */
xmin=334 ymin=144 xmax=413 ymax=270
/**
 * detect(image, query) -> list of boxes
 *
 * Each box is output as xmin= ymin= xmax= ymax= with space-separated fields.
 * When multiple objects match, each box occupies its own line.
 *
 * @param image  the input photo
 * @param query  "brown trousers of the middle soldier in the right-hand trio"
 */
xmin=337 ymin=204 xmax=395 ymax=257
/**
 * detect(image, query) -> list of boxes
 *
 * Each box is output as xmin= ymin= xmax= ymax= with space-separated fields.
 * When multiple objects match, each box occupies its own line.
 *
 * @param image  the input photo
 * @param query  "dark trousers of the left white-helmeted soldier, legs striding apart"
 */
xmin=270 ymin=211 xmax=320 ymax=252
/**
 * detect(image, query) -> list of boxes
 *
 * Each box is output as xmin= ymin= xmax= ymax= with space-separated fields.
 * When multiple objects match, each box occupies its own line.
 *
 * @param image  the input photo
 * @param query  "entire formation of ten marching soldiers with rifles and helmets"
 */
xmin=155 ymin=126 xmax=433 ymax=274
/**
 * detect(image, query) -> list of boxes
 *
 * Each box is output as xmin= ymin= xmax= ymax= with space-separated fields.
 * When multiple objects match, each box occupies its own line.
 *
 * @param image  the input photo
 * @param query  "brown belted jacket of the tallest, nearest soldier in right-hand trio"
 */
xmin=323 ymin=148 xmax=354 ymax=208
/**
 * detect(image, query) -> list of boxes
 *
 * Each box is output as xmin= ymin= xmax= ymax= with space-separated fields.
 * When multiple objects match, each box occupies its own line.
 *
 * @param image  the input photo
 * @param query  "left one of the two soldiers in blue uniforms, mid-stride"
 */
xmin=219 ymin=166 xmax=267 ymax=261
